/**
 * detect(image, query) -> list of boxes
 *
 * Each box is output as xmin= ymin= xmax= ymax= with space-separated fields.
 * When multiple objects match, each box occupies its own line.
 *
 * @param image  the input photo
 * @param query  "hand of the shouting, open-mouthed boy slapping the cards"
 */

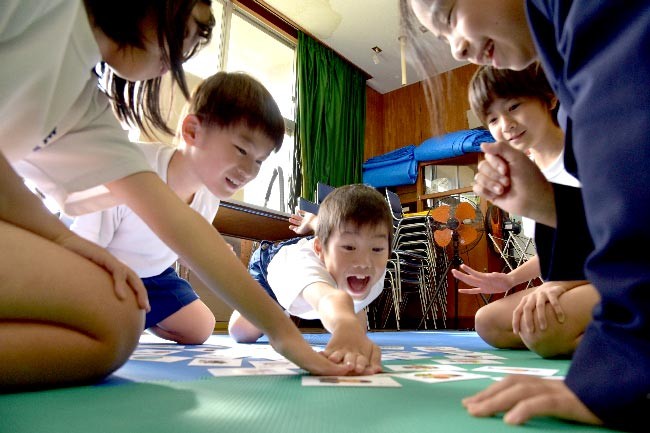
xmin=323 ymin=321 xmax=382 ymax=375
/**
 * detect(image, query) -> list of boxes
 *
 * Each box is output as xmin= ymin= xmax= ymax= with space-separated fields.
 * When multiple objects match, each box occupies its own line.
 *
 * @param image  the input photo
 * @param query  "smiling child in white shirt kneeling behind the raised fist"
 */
xmin=452 ymin=64 xmax=599 ymax=357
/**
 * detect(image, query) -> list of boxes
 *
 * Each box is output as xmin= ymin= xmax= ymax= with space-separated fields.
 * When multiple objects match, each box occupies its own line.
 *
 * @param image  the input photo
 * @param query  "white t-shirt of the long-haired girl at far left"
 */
xmin=0 ymin=0 xmax=151 ymax=215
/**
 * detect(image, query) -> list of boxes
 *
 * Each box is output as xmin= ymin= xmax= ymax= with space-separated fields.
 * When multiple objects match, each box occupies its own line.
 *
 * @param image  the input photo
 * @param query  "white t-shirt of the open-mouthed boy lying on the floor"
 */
xmin=267 ymin=238 xmax=384 ymax=320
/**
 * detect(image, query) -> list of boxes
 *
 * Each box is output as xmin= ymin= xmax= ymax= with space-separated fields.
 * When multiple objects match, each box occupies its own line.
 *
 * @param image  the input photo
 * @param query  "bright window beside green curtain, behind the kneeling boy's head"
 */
xmin=185 ymin=0 xmax=295 ymax=211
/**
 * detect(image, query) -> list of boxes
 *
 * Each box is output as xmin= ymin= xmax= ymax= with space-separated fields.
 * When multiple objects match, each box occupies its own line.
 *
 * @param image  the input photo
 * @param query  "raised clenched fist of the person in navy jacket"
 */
xmin=473 ymin=142 xmax=556 ymax=227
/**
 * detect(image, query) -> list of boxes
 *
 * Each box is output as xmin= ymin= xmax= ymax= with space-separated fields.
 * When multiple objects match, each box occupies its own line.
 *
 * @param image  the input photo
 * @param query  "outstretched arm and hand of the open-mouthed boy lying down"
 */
xmin=303 ymin=282 xmax=381 ymax=374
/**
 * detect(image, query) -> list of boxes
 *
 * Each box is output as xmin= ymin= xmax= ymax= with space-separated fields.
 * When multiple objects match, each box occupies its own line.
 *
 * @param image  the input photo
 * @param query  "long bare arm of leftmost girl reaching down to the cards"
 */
xmin=107 ymin=172 xmax=350 ymax=375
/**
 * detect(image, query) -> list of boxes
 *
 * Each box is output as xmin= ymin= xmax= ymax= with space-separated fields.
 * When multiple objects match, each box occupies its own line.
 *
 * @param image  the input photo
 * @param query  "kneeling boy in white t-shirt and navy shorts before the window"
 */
xmin=71 ymin=72 xmax=284 ymax=344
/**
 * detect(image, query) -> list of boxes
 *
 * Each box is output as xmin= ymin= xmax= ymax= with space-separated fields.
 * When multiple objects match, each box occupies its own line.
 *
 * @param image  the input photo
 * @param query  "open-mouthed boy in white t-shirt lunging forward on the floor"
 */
xmin=228 ymin=184 xmax=393 ymax=373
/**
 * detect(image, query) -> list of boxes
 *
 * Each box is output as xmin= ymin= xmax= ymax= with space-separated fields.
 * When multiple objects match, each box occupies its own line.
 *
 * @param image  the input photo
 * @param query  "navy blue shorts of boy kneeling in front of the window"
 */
xmin=142 ymin=268 xmax=199 ymax=329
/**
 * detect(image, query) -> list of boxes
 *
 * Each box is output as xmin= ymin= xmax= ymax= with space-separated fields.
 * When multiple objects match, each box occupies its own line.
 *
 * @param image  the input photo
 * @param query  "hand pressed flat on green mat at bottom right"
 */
xmin=463 ymin=375 xmax=602 ymax=424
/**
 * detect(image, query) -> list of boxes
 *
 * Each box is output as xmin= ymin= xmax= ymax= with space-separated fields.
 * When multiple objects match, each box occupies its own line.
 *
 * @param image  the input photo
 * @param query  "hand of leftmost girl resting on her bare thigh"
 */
xmin=54 ymin=230 xmax=151 ymax=312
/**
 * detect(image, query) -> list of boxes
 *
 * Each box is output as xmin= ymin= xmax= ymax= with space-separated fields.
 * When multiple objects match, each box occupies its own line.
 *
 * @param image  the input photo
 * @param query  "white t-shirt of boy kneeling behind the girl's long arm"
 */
xmin=70 ymin=143 xmax=219 ymax=278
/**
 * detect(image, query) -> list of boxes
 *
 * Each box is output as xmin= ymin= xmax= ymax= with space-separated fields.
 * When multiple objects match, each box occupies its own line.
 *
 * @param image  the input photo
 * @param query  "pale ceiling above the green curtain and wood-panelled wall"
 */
xmin=260 ymin=0 xmax=464 ymax=93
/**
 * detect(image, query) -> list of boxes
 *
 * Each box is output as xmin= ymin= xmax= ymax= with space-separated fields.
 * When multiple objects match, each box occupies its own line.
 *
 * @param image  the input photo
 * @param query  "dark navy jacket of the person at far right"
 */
xmin=526 ymin=0 xmax=650 ymax=430
